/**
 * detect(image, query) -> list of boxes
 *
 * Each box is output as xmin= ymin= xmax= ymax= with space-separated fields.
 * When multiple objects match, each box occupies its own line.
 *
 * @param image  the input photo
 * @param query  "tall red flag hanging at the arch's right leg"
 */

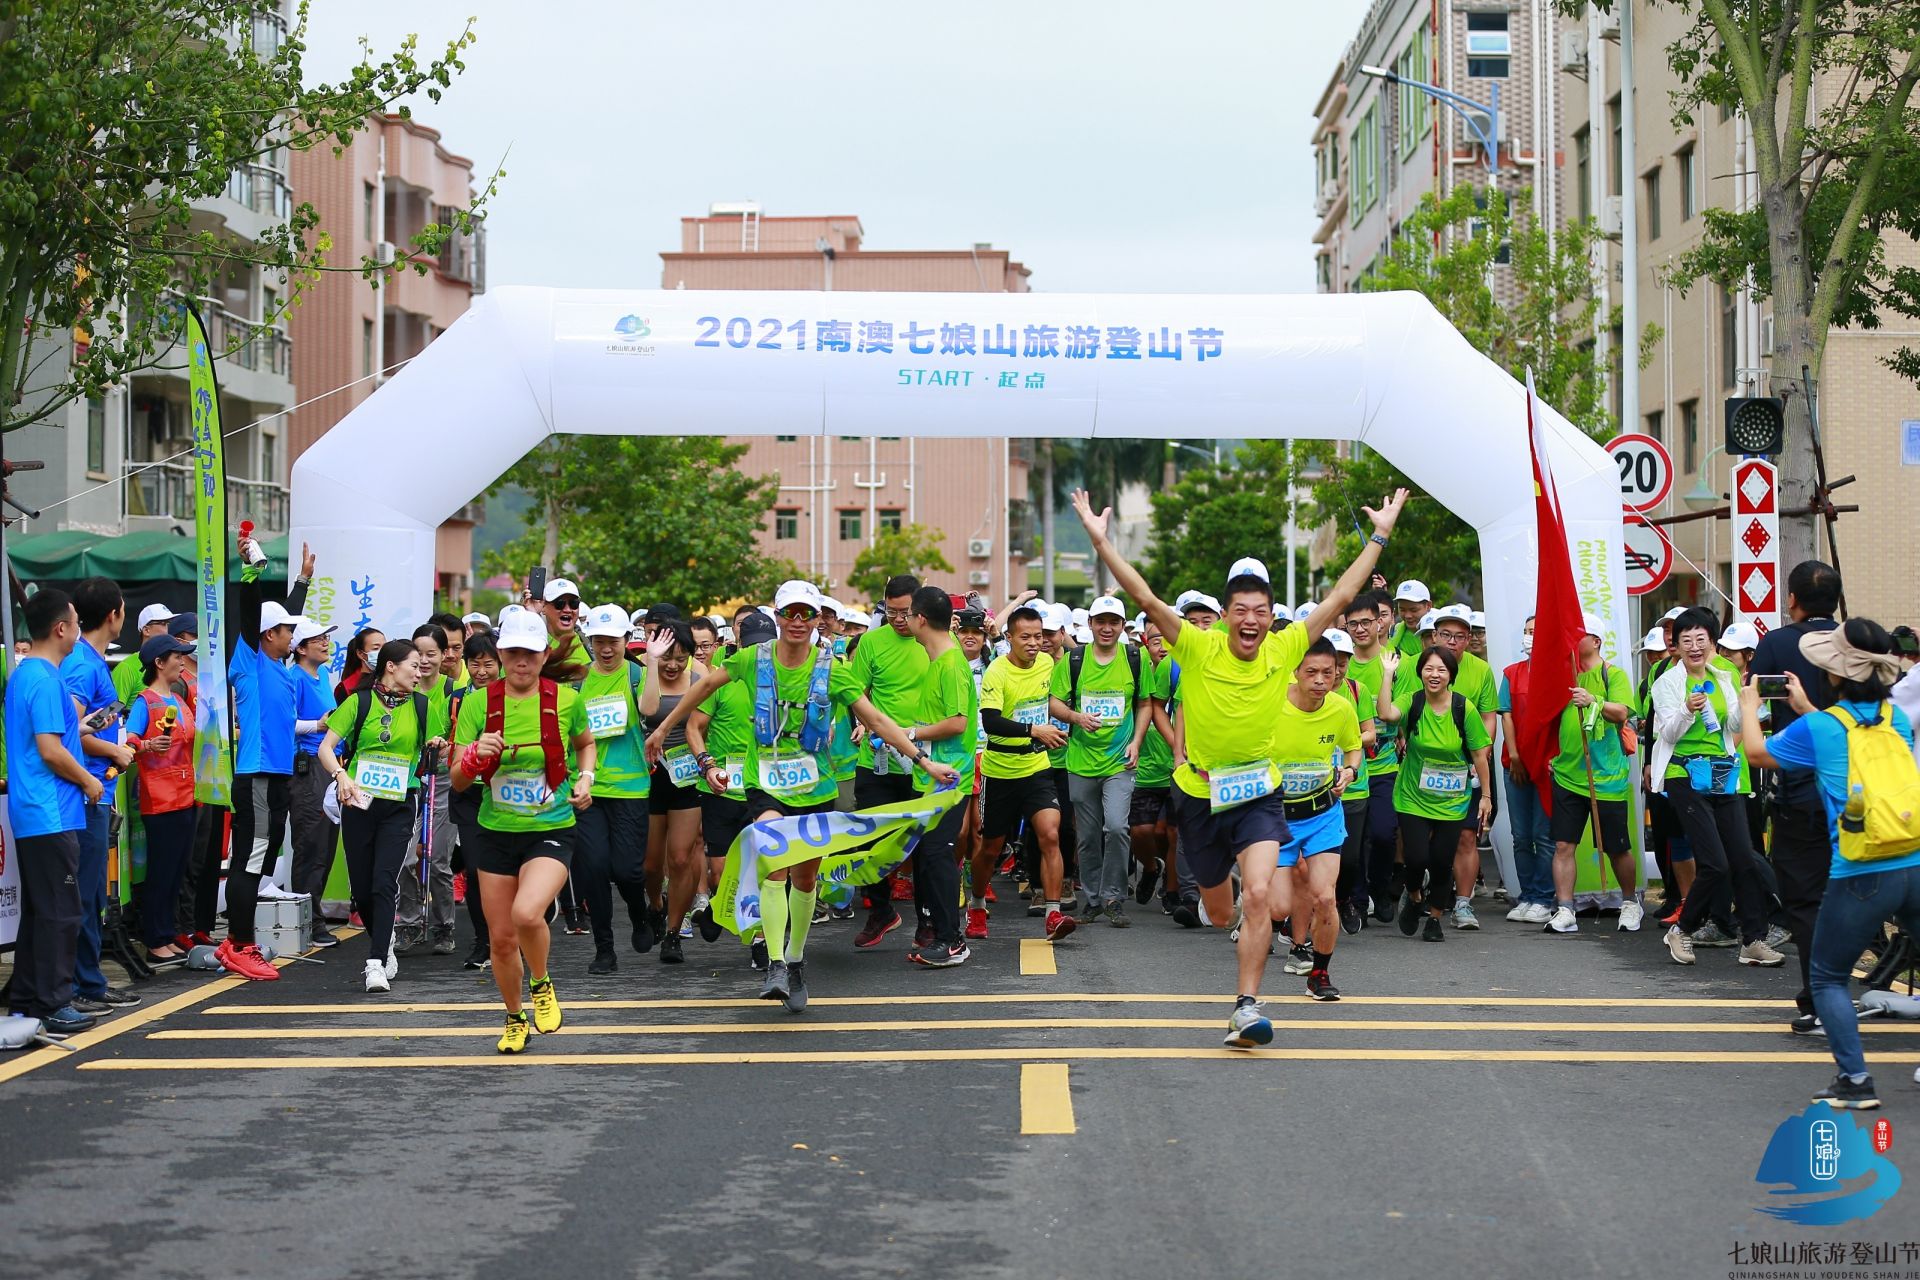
xmin=1513 ymin=370 xmax=1586 ymax=812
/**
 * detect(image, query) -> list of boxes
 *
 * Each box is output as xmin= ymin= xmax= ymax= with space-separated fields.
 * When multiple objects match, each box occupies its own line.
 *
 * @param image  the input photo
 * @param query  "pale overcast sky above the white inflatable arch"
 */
xmin=296 ymin=0 xmax=1367 ymax=294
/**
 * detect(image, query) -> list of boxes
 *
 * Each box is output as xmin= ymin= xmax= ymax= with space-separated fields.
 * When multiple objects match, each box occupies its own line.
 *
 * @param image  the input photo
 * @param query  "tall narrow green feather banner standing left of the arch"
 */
xmin=182 ymin=303 xmax=234 ymax=806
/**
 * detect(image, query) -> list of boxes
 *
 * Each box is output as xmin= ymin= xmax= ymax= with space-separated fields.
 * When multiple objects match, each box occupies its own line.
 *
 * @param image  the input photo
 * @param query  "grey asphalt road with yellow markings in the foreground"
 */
xmin=0 ymin=900 xmax=1920 ymax=1280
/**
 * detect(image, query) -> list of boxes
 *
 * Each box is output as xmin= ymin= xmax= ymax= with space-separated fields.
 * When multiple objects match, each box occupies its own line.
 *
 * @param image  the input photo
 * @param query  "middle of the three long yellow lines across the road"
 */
xmin=146 ymin=1006 xmax=1920 ymax=1040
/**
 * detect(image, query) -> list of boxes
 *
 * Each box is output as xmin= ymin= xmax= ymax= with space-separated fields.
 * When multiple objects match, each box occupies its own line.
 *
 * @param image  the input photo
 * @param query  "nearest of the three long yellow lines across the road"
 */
xmin=79 ymin=1046 xmax=1920 ymax=1071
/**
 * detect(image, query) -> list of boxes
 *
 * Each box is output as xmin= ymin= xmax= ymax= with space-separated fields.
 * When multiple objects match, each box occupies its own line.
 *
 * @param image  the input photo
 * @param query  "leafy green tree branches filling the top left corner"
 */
xmin=0 ymin=0 xmax=499 ymax=432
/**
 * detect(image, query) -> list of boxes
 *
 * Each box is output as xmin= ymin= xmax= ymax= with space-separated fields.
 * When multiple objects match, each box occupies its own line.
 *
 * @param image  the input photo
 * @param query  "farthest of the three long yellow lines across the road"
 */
xmin=202 ymin=990 xmax=1797 ymax=1025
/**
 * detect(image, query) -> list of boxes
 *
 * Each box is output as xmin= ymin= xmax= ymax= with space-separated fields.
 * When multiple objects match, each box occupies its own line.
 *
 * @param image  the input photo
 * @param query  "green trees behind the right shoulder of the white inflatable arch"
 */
xmin=1298 ymin=186 xmax=1659 ymax=597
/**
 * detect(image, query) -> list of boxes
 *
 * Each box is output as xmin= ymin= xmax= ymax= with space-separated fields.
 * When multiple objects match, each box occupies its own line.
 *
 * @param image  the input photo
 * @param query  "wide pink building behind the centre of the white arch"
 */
xmin=660 ymin=203 xmax=1033 ymax=604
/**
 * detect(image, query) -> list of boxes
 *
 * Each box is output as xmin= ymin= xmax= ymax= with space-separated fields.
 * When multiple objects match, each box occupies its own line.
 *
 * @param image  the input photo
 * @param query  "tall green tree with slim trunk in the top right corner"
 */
xmin=1597 ymin=0 xmax=1920 ymax=564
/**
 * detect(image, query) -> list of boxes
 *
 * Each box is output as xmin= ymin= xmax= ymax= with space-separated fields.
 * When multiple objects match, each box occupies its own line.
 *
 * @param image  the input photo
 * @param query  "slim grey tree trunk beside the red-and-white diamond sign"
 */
xmin=1758 ymin=188 xmax=1826 ymax=571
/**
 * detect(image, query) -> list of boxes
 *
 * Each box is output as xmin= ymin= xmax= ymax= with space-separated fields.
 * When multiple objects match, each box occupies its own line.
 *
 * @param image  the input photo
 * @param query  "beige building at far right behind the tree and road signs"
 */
xmin=1561 ymin=0 xmax=1920 ymax=624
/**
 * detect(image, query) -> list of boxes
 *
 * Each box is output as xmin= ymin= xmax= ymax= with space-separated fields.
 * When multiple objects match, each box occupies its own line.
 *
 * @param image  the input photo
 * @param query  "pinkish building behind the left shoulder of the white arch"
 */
xmin=286 ymin=115 xmax=486 ymax=601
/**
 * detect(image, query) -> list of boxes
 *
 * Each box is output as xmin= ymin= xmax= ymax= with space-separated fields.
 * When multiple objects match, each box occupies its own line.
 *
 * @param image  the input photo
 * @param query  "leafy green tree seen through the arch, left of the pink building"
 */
xmin=484 ymin=436 xmax=791 ymax=608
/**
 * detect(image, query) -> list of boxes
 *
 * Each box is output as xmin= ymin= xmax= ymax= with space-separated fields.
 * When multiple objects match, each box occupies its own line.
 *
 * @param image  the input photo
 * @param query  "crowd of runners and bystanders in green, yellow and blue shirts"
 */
xmin=6 ymin=514 xmax=1920 ymax=1105
